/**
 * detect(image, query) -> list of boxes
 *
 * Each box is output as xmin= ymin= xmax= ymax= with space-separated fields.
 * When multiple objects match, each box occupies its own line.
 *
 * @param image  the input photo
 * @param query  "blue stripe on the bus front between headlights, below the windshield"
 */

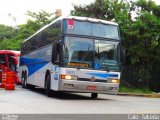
xmin=87 ymin=73 xmax=118 ymax=78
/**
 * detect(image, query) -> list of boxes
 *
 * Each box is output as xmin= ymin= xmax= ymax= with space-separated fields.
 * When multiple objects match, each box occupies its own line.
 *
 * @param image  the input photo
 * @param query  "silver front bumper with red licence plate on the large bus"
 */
xmin=59 ymin=80 xmax=119 ymax=94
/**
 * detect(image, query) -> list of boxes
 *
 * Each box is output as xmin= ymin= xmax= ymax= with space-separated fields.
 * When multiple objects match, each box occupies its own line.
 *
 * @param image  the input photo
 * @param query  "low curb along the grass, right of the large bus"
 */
xmin=117 ymin=93 xmax=160 ymax=98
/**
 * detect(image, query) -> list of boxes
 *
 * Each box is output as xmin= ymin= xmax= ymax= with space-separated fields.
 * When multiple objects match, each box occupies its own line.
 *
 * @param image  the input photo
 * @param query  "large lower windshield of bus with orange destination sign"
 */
xmin=63 ymin=37 xmax=119 ymax=71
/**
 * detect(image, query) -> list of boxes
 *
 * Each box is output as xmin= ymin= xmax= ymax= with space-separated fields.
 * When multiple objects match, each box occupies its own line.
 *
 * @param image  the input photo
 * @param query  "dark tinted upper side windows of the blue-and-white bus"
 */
xmin=21 ymin=21 xmax=61 ymax=54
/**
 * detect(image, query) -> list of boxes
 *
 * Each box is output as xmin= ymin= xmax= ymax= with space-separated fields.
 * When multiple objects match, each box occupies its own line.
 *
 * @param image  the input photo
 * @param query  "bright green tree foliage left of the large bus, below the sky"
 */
xmin=0 ymin=11 xmax=54 ymax=50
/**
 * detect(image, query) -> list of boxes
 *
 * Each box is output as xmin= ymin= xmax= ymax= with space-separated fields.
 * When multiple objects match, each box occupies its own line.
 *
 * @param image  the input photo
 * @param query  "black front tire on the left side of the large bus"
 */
xmin=45 ymin=75 xmax=52 ymax=97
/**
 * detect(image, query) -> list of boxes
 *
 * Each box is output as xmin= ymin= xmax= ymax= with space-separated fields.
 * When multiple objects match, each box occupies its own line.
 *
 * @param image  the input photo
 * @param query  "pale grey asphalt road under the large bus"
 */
xmin=0 ymin=86 xmax=160 ymax=114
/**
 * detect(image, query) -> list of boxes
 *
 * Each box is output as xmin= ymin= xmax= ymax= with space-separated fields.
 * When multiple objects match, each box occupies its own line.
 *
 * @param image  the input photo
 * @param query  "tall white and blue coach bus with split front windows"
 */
xmin=19 ymin=16 xmax=120 ymax=98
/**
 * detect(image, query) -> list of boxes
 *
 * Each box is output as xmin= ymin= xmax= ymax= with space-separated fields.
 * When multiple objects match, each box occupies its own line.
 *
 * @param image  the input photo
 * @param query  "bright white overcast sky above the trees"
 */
xmin=0 ymin=0 xmax=160 ymax=26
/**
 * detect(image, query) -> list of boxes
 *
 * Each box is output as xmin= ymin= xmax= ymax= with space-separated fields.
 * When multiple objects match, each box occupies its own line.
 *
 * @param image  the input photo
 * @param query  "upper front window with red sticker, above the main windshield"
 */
xmin=64 ymin=20 xmax=119 ymax=40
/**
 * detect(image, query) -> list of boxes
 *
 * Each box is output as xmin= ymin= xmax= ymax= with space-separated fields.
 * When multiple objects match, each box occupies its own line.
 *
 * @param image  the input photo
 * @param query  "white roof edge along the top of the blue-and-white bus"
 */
xmin=22 ymin=16 xmax=118 ymax=43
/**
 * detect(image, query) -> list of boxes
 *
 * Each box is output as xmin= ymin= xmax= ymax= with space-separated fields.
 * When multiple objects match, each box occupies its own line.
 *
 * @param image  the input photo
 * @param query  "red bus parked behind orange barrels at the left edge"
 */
xmin=0 ymin=50 xmax=20 ymax=83
